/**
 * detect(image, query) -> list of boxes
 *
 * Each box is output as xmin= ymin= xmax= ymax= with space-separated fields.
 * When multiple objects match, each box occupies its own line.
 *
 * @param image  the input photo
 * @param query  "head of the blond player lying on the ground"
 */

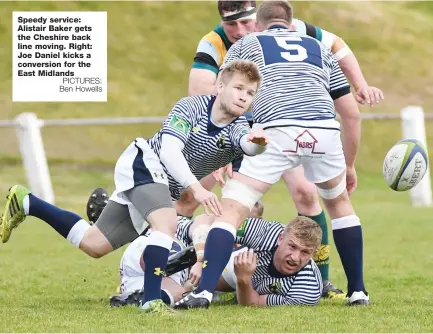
xmin=274 ymin=216 xmax=322 ymax=275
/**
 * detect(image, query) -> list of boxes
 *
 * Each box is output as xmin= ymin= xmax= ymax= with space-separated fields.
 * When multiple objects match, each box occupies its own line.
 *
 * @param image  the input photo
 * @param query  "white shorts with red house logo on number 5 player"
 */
xmin=239 ymin=119 xmax=346 ymax=184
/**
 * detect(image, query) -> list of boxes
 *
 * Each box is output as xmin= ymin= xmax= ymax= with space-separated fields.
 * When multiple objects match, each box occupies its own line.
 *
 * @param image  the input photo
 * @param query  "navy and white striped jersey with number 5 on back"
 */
xmin=222 ymin=26 xmax=350 ymax=124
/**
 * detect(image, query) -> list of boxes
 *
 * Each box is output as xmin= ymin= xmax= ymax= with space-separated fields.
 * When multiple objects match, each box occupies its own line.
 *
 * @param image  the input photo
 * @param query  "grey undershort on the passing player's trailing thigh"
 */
xmin=95 ymin=200 xmax=139 ymax=250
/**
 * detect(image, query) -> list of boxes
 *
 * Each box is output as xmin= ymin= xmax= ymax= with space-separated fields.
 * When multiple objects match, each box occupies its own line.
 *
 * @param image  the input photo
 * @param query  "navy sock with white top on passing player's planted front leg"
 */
xmin=142 ymin=231 xmax=173 ymax=305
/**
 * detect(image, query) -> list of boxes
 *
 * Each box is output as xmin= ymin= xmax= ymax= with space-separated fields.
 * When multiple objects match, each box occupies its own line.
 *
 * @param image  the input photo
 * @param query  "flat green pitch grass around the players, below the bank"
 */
xmin=0 ymin=163 xmax=433 ymax=332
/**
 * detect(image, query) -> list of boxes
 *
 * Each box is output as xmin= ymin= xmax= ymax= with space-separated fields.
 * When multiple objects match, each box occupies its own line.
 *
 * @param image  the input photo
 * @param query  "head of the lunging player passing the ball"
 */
xmin=217 ymin=60 xmax=261 ymax=118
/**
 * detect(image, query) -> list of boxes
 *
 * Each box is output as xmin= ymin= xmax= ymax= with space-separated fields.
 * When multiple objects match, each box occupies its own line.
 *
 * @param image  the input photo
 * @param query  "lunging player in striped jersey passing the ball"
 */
xmin=0 ymin=61 xmax=267 ymax=312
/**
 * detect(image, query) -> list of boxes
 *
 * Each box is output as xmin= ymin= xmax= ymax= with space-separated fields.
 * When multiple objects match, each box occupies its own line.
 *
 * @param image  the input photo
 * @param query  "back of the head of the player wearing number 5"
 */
xmin=257 ymin=0 xmax=293 ymax=31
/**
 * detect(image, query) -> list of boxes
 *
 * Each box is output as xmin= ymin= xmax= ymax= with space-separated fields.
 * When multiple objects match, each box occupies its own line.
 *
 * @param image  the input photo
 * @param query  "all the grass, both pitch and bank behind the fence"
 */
xmin=0 ymin=2 xmax=433 ymax=332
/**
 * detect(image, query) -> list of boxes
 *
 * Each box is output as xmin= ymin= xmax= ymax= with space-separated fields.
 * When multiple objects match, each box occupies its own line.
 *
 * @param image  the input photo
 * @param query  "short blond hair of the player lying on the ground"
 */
xmin=284 ymin=216 xmax=322 ymax=249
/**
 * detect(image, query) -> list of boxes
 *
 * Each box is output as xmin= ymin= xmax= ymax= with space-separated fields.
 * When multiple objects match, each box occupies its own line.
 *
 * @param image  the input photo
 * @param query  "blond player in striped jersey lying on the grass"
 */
xmin=110 ymin=211 xmax=322 ymax=306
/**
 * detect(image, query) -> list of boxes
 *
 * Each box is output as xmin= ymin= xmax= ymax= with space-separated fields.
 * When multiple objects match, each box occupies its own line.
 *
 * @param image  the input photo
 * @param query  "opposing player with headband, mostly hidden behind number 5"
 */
xmin=178 ymin=0 xmax=383 ymax=298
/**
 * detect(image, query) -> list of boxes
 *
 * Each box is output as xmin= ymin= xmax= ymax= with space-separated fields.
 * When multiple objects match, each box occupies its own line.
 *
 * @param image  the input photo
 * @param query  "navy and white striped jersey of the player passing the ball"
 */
xmin=148 ymin=95 xmax=250 ymax=199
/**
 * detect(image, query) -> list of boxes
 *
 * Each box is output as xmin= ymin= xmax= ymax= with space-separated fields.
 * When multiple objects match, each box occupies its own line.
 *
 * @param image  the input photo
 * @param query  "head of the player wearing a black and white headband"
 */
xmin=218 ymin=0 xmax=256 ymax=43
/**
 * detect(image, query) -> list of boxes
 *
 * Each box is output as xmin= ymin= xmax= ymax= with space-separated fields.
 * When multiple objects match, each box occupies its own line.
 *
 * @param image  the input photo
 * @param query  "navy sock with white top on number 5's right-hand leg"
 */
xmin=332 ymin=215 xmax=365 ymax=296
